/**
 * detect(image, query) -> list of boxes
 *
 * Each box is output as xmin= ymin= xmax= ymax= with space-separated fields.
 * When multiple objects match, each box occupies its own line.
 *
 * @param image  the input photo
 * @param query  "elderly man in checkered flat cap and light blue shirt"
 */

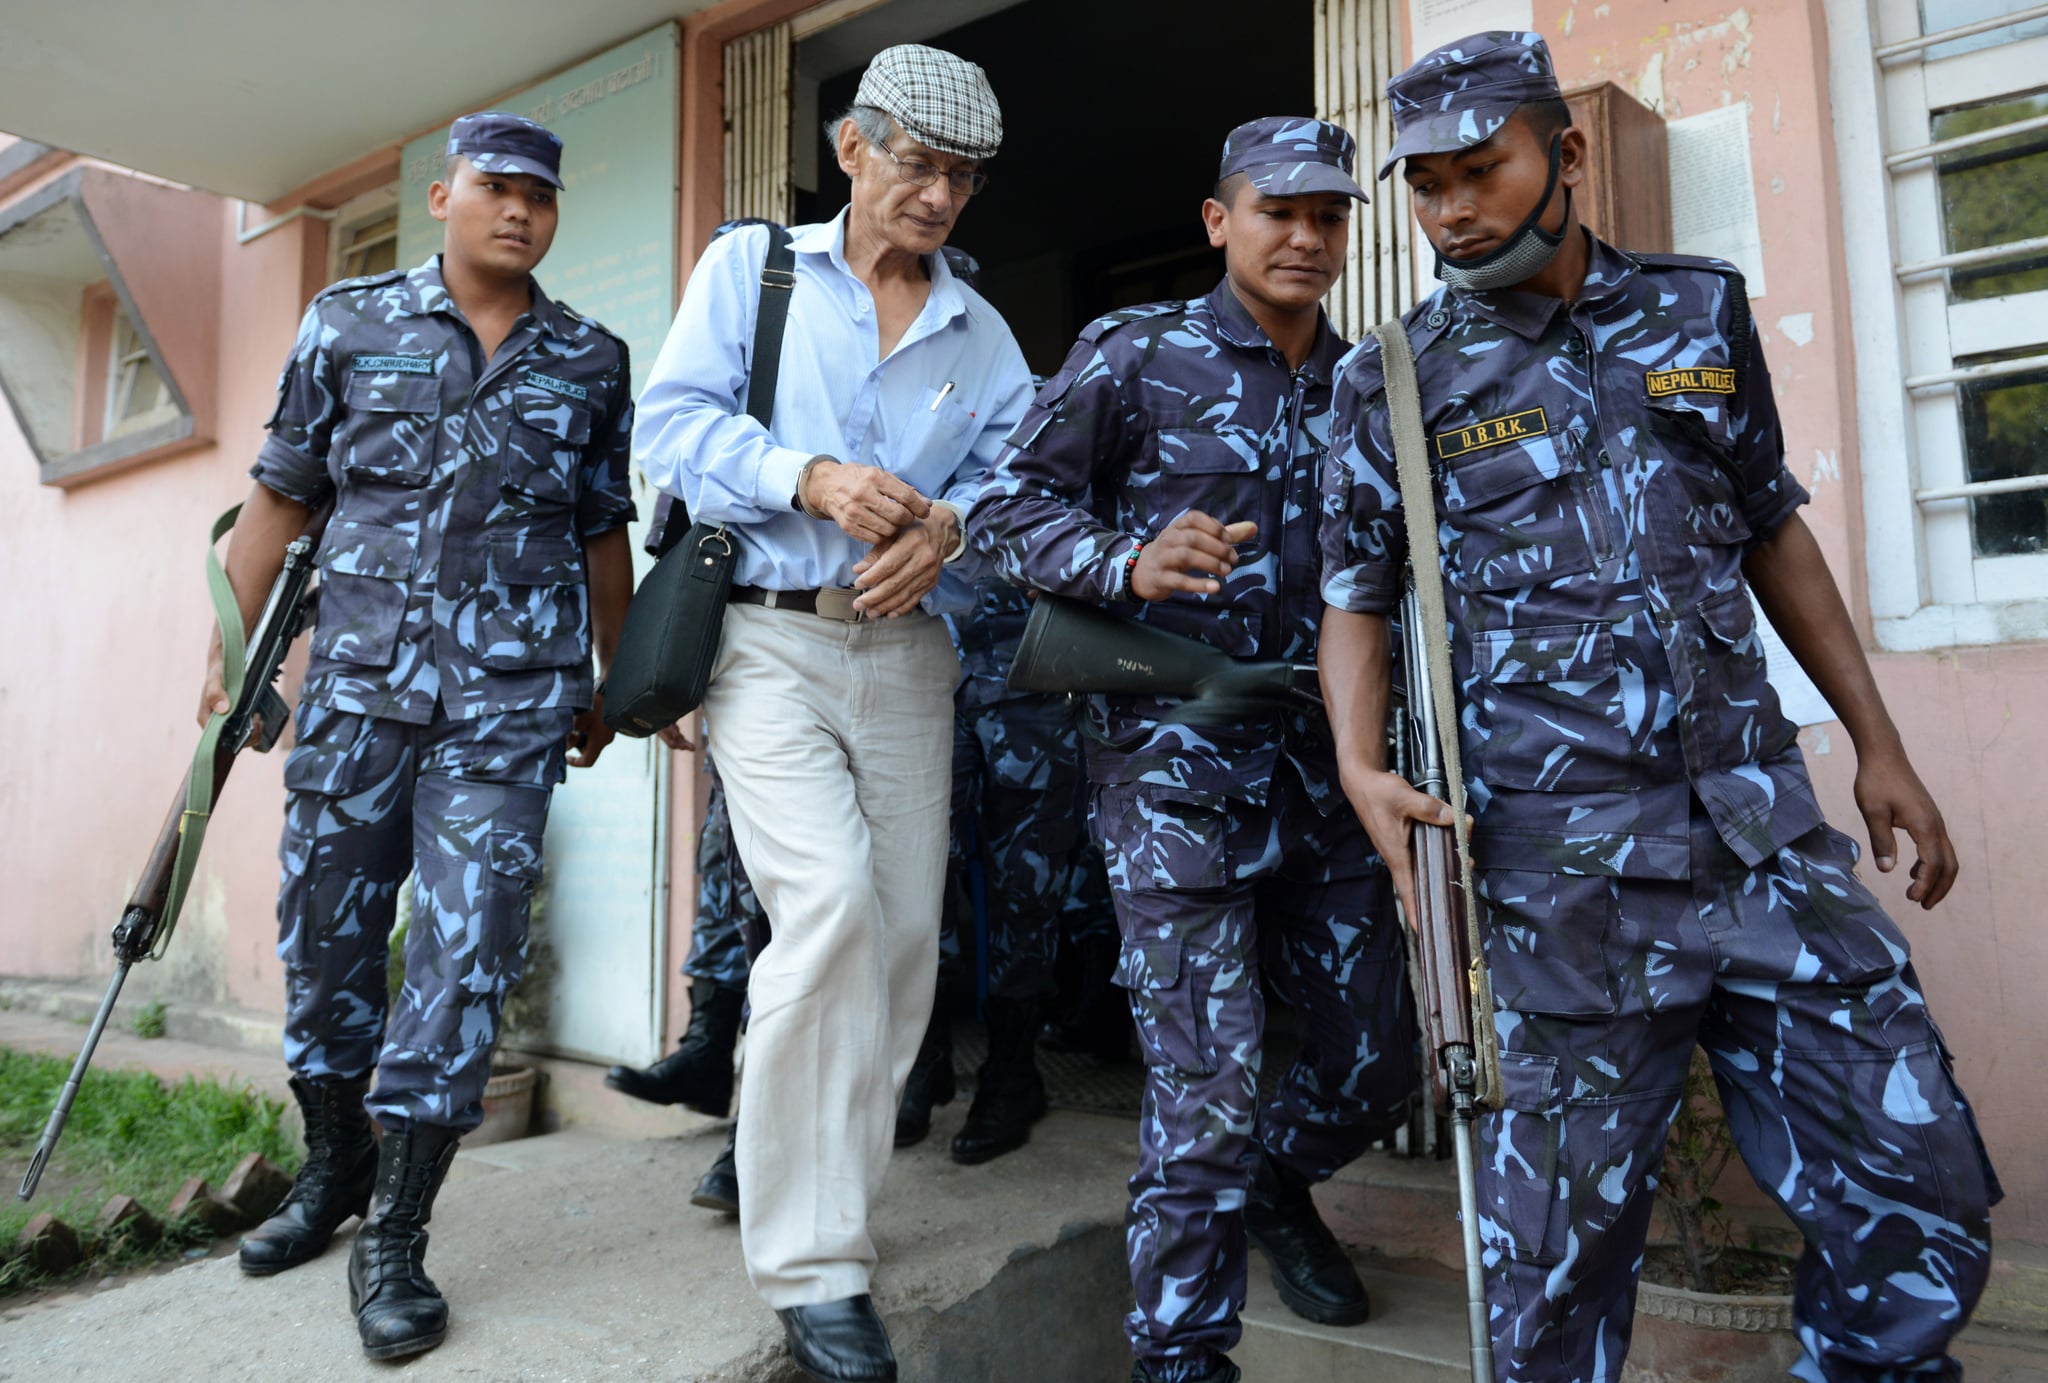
xmin=633 ymin=45 xmax=1030 ymax=1379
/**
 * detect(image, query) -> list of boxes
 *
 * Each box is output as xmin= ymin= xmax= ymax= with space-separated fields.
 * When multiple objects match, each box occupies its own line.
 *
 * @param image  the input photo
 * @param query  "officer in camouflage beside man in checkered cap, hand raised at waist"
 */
xmin=971 ymin=119 xmax=1415 ymax=1383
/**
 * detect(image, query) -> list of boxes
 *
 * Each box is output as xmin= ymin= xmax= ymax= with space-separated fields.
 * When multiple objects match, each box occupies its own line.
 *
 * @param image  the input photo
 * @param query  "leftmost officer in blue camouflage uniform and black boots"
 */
xmin=203 ymin=113 xmax=633 ymax=1358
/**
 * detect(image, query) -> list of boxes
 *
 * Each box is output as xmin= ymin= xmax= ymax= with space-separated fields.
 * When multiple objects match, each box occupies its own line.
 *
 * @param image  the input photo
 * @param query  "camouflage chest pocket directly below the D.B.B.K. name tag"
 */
xmin=1438 ymin=424 xmax=1599 ymax=590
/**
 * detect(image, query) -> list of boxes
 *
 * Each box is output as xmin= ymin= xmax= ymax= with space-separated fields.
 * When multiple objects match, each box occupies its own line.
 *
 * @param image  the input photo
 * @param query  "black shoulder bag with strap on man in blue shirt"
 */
xmin=604 ymin=221 xmax=797 ymax=738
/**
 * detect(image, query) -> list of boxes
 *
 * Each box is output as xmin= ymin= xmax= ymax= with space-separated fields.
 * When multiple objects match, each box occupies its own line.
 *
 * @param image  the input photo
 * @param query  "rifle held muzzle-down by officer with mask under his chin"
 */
xmin=1393 ymin=582 xmax=1501 ymax=1383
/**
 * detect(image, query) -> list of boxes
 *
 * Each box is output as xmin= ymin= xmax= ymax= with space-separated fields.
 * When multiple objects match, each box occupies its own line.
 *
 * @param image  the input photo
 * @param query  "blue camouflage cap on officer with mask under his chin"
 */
xmin=1380 ymin=29 xmax=1559 ymax=178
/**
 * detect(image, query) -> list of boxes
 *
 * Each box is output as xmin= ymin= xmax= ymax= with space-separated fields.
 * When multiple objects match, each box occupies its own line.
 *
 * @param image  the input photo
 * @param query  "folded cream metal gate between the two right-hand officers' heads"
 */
xmin=1315 ymin=0 xmax=1419 ymax=340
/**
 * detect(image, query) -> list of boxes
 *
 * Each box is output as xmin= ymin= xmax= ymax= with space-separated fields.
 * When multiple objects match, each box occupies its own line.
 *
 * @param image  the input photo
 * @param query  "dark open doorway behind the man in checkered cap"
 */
xmin=795 ymin=0 xmax=1315 ymax=375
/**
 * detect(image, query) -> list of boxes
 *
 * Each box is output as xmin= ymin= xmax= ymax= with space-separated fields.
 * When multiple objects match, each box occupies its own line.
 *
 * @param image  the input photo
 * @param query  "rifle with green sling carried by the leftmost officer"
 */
xmin=16 ymin=504 xmax=322 ymax=1201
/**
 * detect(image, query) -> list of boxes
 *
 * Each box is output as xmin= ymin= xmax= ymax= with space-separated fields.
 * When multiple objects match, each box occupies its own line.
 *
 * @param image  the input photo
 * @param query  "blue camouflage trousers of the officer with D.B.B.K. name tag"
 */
xmin=1477 ymin=807 xmax=1999 ymax=1383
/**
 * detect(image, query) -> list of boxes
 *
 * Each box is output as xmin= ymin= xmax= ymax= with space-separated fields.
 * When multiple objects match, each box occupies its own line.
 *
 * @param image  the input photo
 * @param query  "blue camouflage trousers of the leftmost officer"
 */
xmin=276 ymin=703 xmax=575 ymax=1131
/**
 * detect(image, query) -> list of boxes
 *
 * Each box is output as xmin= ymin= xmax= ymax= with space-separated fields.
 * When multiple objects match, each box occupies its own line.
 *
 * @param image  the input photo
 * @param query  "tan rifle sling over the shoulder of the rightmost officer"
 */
xmin=1372 ymin=320 xmax=1479 ymax=909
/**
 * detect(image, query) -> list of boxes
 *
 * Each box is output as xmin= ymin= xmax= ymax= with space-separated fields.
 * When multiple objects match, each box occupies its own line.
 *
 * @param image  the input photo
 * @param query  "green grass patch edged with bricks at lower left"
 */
xmin=0 ymin=1047 xmax=301 ymax=1295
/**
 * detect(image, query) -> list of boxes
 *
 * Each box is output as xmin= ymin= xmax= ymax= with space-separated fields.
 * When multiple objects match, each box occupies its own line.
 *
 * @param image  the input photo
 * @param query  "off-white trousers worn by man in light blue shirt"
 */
xmin=705 ymin=604 xmax=958 ymax=1309
